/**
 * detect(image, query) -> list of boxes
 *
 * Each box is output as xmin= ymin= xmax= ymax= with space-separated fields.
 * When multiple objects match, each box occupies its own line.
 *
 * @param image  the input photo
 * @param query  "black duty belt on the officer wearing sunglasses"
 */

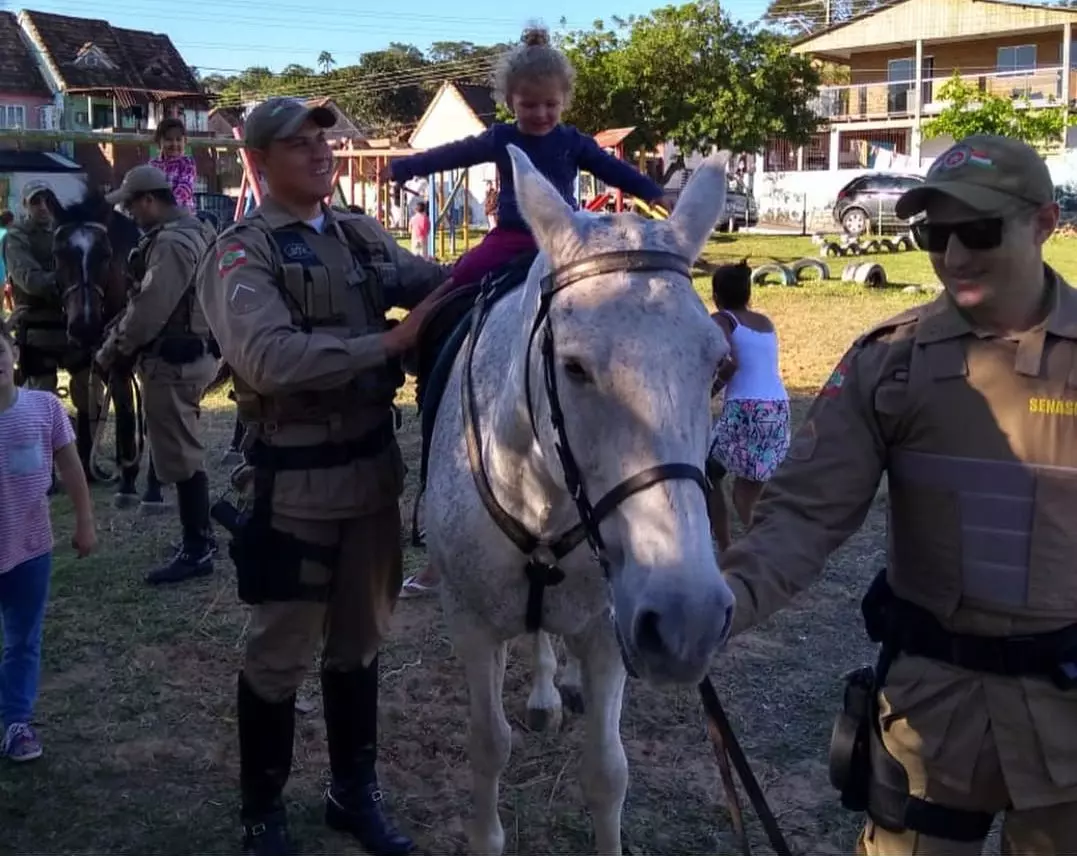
xmin=864 ymin=572 xmax=1077 ymax=689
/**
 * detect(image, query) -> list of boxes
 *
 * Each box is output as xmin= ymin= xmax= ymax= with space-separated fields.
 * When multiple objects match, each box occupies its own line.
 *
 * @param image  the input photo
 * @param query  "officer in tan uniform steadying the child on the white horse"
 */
xmin=198 ymin=98 xmax=449 ymax=856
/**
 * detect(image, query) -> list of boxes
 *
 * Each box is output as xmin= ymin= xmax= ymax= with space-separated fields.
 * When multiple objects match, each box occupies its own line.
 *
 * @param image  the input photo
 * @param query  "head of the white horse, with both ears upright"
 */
xmin=509 ymin=148 xmax=733 ymax=684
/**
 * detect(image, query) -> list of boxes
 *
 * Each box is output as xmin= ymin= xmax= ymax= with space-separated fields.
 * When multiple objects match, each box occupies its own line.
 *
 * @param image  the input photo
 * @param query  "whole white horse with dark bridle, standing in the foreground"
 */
xmin=425 ymin=148 xmax=733 ymax=856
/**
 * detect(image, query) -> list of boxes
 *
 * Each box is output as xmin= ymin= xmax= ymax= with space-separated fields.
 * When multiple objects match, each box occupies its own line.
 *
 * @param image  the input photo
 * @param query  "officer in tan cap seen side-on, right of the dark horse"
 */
xmin=97 ymin=165 xmax=218 ymax=584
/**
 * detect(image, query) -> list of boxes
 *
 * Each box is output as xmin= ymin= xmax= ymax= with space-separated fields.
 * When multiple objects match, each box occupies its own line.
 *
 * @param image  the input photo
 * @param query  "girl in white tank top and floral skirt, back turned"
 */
xmin=708 ymin=261 xmax=789 ymax=550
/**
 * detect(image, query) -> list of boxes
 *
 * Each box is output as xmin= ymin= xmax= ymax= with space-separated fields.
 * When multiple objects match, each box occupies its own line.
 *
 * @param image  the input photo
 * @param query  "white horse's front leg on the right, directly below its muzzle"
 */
xmin=564 ymin=615 xmax=628 ymax=856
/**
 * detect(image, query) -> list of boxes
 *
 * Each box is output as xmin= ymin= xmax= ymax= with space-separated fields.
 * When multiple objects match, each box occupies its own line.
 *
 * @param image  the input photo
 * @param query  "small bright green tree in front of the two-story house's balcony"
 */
xmin=923 ymin=72 xmax=1073 ymax=149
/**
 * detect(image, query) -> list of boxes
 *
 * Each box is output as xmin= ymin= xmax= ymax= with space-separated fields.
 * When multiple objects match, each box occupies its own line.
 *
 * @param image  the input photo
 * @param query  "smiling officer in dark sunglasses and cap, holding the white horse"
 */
xmin=724 ymin=136 xmax=1077 ymax=856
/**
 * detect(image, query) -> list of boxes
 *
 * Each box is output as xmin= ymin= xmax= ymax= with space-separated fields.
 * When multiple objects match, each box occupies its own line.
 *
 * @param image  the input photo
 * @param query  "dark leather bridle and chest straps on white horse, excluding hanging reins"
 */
xmin=460 ymin=250 xmax=710 ymax=663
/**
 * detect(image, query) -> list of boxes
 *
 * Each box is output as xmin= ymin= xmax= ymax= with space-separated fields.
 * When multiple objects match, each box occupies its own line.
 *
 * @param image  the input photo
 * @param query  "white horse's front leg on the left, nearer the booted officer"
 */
xmin=445 ymin=592 xmax=513 ymax=856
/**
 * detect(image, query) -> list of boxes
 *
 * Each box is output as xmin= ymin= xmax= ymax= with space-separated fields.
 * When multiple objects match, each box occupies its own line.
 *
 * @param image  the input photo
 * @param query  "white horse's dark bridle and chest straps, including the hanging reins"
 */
xmin=460 ymin=250 xmax=791 ymax=856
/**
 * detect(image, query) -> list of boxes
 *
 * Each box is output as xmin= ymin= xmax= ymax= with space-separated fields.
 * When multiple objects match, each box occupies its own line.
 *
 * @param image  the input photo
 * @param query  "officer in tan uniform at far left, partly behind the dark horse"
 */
xmin=3 ymin=180 xmax=104 ymax=481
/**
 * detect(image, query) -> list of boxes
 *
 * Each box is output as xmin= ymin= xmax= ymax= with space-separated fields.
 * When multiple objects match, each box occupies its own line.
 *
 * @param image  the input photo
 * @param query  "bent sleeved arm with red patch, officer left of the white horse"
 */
xmin=197 ymin=227 xmax=387 ymax=395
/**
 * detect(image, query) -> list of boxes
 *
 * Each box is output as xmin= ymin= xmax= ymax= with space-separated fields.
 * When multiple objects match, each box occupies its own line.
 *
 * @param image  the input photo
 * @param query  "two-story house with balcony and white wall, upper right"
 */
xmin=755 ymin=0 xmax=1077 ymax=227
